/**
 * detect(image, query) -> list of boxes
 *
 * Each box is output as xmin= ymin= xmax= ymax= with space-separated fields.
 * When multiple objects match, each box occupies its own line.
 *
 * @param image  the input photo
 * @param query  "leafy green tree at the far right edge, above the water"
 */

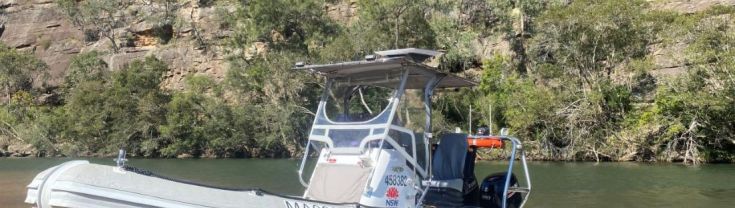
xmin=655 ymin=7 xmax=735 ymax=163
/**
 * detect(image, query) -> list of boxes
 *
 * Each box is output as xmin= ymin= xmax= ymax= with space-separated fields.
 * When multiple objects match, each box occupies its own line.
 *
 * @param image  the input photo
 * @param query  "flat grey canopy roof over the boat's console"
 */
xmin=294 ymin=48 xmax=476 ymax=89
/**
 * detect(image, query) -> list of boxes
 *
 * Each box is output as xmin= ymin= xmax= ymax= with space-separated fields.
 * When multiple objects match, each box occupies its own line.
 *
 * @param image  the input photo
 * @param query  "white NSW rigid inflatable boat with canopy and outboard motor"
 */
xmin=25 ymin=48 xmax=531 ymax=208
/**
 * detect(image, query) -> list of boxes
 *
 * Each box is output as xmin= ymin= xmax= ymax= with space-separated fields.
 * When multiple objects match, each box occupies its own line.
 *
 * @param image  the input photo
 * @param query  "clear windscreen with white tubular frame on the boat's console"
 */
xmin=309 ymin=68 xmax=429 ymax=179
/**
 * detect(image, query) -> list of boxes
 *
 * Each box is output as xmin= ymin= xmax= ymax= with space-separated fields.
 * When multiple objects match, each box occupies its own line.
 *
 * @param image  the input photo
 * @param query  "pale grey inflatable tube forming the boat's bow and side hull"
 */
xmin=25 ymin=161 xmax=358 ymax=208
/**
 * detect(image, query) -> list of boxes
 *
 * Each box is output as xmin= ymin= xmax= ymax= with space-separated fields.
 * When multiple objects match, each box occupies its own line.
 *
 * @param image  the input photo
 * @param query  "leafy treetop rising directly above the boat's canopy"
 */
xmin=318 ymin=0 xmax=440 ymax=62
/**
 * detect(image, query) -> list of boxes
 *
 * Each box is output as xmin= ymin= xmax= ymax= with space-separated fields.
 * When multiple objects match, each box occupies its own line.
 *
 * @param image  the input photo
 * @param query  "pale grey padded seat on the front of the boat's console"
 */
xmin=304 ymin=163 xmax=373 ymax=203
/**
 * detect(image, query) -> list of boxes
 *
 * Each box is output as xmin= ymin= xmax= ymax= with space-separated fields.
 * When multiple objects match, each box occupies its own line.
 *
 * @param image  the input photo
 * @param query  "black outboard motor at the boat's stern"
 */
xmin=480 ymin=172 xmax=523 ymax=208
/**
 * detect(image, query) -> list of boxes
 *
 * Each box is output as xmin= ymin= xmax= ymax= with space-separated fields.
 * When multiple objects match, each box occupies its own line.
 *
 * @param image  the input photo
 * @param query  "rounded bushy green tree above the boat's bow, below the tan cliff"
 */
xmin=64 ymin=54 xmax=169 ymax=153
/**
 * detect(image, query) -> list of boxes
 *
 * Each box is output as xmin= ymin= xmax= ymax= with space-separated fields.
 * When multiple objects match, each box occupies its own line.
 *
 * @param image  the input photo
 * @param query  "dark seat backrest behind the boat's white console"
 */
xmin=431 ymin=133 xmax=468 ymax=180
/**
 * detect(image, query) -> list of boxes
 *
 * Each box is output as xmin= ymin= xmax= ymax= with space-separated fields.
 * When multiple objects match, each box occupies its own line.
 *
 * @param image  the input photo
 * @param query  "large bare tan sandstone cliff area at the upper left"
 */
xmin=0 ymin=0 xmax=227 ymax=89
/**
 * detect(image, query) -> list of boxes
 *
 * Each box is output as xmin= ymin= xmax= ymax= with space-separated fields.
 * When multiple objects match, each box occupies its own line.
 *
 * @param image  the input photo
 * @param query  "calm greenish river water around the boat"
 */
xmin=0 ymin=158 xmax=735 ymax=208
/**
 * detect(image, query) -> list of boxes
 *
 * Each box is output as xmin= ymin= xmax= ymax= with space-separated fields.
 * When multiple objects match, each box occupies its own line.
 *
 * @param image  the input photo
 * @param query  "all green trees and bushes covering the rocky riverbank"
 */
xmin=0 ymin=0 xmax=735 ymax=163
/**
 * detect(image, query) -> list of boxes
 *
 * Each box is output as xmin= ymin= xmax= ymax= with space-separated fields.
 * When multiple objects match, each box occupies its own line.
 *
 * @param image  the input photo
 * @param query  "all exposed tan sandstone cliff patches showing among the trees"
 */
xmin=0 ymin=0 xmax=735 ymax=89
